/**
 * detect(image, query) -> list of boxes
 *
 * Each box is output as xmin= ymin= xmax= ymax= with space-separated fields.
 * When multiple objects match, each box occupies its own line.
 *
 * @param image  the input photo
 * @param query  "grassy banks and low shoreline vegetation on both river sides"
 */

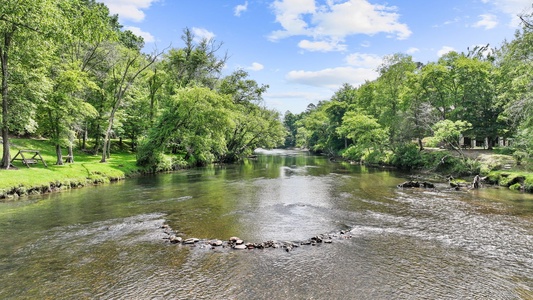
xmin=0 ymin=138 xmax=533 ymax=201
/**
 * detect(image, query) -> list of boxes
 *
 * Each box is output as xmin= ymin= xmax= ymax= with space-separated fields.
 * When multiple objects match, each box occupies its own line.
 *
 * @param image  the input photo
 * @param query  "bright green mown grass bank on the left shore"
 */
xmin=0 ymin=139 xmax=139 ymax=198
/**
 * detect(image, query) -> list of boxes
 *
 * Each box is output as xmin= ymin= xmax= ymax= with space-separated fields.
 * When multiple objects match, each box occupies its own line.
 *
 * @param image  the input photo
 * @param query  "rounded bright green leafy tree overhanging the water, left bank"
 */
xmin=137 ymin=87 xmax=233 ymax=169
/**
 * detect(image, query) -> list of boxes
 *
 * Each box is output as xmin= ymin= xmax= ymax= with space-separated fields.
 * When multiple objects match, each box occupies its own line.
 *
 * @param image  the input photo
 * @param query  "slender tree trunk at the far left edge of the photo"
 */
xmin=0 ymin=33 xmax=11 ymax=169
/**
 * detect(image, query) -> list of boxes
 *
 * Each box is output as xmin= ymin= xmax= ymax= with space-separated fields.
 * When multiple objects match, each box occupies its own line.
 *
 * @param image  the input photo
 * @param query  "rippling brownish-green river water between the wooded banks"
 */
xmin=0 ymin=151 xmax=533 ymax=299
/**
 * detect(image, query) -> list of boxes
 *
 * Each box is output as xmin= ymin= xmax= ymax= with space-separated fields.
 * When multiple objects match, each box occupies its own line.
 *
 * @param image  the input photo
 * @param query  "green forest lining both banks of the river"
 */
xmin=0 ymin=0 xmax=533 ymax=178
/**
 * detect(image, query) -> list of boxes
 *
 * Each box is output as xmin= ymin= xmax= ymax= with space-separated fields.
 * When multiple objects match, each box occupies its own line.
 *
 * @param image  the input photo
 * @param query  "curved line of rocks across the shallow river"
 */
xmin=160 ymin=224 xmax=352 ymax=252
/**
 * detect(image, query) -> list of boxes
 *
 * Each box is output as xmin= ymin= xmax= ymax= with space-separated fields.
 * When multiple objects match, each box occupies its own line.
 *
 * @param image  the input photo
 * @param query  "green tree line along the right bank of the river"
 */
xmin=284 ymin=11 xmax=533 ymax=168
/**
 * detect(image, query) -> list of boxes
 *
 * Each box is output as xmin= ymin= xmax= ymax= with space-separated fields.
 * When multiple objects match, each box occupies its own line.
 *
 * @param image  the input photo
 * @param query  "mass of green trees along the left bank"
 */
xmin=0 ymin=0 xmax=285 ymax=171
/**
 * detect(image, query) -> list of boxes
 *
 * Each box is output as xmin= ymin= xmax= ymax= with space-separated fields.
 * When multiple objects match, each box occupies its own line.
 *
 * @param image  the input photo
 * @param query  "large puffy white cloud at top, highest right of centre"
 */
xmin=269 ymin=0 xmax=411 ymax=51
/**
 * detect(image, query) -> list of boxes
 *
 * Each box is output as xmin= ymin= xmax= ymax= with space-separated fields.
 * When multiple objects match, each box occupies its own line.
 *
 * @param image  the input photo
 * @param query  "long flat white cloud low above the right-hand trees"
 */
xmin=285 ymin=67 xmax=378 ymax=90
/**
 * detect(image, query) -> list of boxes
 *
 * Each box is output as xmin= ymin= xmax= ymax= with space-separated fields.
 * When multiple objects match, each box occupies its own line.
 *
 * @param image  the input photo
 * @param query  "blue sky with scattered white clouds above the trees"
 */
xmin=99 ymin=0 xmax=532 ymax=113
